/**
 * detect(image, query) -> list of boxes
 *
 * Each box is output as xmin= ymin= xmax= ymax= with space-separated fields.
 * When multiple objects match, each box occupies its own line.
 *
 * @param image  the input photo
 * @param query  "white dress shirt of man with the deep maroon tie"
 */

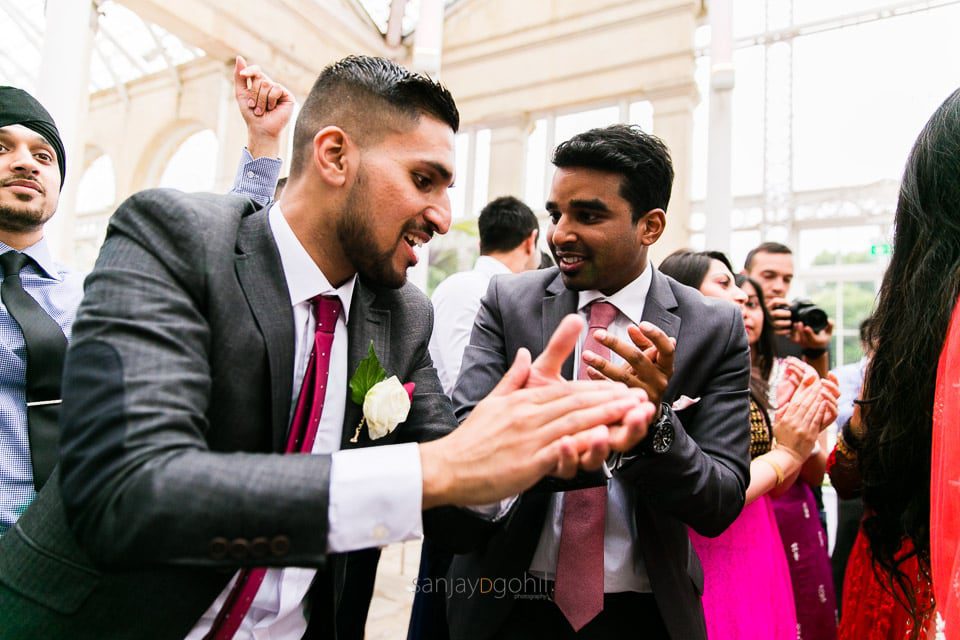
xmin=187 ymin=204 xmax=423 ymax=640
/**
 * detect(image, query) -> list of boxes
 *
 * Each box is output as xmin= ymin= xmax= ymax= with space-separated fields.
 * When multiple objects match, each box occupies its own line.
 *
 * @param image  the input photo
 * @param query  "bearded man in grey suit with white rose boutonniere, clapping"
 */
xmin=0 ymin=57 xmax=655 ymax=639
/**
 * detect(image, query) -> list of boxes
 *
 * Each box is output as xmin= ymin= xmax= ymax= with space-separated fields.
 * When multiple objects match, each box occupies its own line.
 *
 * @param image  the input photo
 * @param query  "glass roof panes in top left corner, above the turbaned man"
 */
xmin=0 ymin=0 xmax=204 ymax=92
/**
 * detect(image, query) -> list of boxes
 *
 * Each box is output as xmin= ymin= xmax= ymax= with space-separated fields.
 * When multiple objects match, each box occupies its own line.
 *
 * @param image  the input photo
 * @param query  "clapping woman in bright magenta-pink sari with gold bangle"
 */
xmin=660 ymin=251 xmax=836 ymax=640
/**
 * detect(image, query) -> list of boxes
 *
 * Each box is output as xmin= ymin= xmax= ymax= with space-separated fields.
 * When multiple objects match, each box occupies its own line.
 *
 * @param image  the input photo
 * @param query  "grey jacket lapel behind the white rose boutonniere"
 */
xmin=340 ymin=278 xmax=394 ymax=449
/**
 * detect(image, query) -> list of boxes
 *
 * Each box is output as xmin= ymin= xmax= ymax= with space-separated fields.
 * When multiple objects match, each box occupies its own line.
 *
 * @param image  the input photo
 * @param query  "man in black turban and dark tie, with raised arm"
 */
xmin=0 ymin=74 xmax=292 ymax=544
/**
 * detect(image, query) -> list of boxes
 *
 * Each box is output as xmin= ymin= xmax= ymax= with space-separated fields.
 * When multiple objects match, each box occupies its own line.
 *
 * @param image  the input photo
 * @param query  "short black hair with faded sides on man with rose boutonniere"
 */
xmin=290 ymin=56 xmax=460 ymax=175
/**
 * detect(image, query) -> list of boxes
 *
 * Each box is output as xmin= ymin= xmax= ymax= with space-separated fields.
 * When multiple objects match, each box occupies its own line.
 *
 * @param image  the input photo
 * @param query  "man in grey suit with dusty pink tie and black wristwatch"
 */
xmin=446 ymin=125 xmax=750 ymax=640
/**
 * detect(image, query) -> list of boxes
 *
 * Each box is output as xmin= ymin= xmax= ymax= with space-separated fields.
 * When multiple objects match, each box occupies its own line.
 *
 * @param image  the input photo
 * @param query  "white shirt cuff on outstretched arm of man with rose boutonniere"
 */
xmin=327 ymin=443 xmax=423 ymax=553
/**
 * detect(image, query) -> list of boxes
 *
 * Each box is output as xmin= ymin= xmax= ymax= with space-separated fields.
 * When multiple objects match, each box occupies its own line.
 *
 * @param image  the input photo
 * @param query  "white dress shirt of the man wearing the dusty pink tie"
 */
xmin=530 ymin=263 xmax=653 ymax=593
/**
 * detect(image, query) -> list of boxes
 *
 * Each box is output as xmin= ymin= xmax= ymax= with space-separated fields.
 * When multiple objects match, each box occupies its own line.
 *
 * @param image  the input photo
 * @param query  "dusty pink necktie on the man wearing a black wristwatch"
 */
xmin=553 ymin=300 xmax=617 ymax=631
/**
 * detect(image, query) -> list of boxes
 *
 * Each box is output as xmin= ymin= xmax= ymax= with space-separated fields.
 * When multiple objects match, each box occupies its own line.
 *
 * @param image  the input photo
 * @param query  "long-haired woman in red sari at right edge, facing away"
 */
xmin=834 ymin=90 xmax=960 ymax=640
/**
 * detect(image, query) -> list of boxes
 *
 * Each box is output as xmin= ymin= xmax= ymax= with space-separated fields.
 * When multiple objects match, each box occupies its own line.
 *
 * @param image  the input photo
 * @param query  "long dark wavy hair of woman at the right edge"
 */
xmin=858 ymin=85 xmax=960 ymax=617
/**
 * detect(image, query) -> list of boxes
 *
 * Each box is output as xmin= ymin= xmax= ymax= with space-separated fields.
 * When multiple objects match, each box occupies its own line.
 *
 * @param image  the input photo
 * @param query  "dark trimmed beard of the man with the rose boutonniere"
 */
xmin=337 ymin=167 xmax=407 ymax=289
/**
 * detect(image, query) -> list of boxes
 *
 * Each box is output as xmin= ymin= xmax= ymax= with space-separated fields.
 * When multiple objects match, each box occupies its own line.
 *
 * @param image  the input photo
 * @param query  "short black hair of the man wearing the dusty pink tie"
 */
xmin=553 ymin=124 xmax=673 ymax=224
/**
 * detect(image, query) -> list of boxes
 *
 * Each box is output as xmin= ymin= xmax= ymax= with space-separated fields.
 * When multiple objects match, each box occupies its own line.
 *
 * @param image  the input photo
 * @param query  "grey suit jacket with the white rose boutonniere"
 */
xmin=0 ymin=190 xmax=476 ymax=638
